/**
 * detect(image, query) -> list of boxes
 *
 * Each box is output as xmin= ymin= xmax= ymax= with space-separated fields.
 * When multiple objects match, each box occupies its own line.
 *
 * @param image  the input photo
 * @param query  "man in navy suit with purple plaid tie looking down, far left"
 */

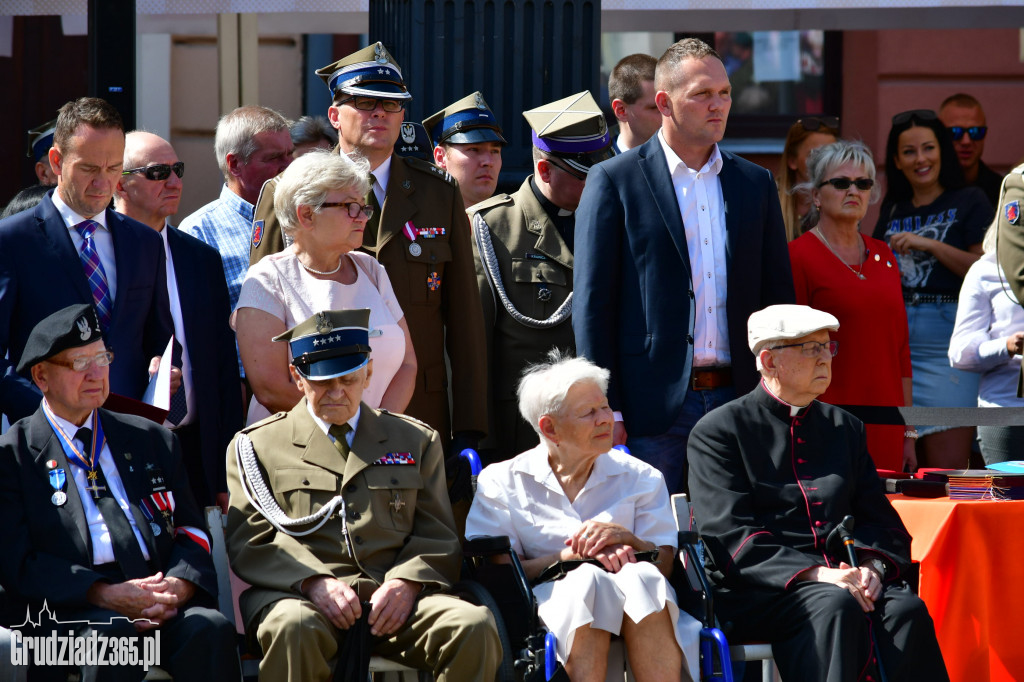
xmin=0 ymin=97 xmax=180 ymax=423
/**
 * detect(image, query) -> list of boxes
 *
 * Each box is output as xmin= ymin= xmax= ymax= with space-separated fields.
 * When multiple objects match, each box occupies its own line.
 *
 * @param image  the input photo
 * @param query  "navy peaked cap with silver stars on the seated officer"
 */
xmin=273 ymin=308 xmax=370 ymax=381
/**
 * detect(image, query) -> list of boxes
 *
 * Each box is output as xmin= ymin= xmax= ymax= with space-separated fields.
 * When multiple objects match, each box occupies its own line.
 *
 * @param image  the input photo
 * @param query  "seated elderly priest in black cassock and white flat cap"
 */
xmin=688 ymin=305 xmax=949 ymax=682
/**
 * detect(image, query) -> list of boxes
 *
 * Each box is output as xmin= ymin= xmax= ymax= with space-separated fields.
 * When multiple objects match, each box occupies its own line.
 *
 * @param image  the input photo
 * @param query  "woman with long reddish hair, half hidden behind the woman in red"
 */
xmin=776 ymin=116 xmax=839 ymax=242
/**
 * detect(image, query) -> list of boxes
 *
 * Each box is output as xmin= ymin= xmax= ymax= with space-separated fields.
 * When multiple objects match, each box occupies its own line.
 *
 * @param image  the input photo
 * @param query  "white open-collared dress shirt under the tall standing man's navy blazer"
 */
xmin=657 ymin=130 xmax=731 ymax=367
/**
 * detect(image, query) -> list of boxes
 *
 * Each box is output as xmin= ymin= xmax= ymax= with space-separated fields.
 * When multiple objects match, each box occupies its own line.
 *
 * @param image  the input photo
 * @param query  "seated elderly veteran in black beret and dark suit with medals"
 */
xmin=0 ymin=304 xmax=241 ymax=680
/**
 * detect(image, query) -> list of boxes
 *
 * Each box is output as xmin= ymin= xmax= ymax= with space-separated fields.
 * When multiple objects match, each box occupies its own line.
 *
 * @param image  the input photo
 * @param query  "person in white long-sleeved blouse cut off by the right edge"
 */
xmin=949 ymin=224 xmax=1024 ymax=464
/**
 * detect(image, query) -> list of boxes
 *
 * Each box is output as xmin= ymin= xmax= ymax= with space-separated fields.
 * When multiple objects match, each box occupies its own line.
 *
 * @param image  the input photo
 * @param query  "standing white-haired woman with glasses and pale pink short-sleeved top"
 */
xmin=231 ymin=151 xmax=416 ymax=424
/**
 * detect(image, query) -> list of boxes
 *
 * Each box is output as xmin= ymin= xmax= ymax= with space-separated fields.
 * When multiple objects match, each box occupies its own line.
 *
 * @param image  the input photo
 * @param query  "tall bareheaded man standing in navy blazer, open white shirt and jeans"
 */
xmin=572 ymin=38 xmax=794 ymax=493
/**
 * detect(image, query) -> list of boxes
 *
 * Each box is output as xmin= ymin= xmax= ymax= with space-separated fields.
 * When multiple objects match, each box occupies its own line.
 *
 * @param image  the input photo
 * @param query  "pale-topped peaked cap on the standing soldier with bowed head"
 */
xmin=522 ymin=90 xmax=615 ymax=175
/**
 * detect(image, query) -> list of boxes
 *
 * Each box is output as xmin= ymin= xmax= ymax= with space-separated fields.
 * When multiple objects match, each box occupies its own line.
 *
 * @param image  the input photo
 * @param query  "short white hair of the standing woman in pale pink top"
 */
xmin=273 ymin=150 xmax=370 ymax=235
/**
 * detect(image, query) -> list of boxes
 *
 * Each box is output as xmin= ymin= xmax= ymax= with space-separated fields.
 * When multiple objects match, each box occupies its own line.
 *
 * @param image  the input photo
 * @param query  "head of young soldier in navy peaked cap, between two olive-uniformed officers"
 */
xmin=423 ymin=91 xmax=506 ymax=208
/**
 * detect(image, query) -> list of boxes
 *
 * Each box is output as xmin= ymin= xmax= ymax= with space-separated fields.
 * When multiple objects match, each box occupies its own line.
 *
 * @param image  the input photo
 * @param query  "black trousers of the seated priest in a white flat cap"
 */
xmin=715 ymin=582 xmax=949 ymax=682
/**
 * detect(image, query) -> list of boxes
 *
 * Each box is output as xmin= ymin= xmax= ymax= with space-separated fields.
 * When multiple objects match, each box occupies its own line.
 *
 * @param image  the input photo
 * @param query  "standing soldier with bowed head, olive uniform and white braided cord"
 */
xmin=471 ymin=91 xmax=612 ymax=462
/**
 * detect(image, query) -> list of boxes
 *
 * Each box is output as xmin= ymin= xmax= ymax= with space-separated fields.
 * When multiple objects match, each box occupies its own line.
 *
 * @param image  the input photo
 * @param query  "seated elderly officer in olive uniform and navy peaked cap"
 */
xmin=226 ymin=309 xmax=502 ymax=682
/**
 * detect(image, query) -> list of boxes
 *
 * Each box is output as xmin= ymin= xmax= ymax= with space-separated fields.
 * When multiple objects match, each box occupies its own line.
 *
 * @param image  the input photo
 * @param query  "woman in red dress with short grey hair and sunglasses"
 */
xmin=790 ymin=140 xmax=916 ymax=471
